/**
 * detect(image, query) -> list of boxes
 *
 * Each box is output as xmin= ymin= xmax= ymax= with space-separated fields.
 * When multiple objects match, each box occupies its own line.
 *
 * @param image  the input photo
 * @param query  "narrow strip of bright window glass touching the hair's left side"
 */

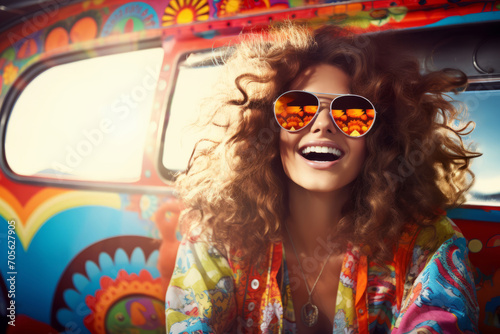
xmin=162 ymin=51 xmax=225 ymax=172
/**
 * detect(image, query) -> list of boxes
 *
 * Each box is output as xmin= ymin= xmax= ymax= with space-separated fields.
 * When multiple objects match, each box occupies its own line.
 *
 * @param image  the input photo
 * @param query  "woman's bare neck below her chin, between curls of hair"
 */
xmin=287 ymin=181 xmax=350 ymax=254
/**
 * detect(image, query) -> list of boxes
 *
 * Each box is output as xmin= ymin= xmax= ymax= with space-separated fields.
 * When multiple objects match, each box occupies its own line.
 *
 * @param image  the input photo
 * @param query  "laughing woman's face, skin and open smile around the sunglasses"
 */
xmin=280 ymin=64 xmax=366 ymax=192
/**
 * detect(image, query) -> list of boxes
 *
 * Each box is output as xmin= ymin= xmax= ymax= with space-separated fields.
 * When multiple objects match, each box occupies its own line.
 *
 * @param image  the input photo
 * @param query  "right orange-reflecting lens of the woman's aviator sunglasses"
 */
xmin=331 ymin=95 xmax=375 ymax=137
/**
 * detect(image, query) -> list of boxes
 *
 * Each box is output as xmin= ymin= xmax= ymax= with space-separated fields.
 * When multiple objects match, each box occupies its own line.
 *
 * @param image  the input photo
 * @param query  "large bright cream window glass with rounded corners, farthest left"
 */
xmin=5 ymin=48 xmax=163 ymax=182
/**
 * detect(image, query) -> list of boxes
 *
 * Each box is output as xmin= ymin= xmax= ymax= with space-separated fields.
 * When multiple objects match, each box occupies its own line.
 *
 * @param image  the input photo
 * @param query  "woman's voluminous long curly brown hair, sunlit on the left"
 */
xmin=176 ymin=23 xmax=480 ymax=261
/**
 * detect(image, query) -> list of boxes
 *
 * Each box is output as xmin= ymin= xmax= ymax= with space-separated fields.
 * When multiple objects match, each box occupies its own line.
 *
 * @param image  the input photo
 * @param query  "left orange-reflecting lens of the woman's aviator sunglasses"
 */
xmin=274 ymin=91 xmax=318 ymax=131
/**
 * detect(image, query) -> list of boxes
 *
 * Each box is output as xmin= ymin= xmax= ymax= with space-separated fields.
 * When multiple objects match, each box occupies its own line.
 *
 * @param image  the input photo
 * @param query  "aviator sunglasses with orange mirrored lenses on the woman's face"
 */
xmin=274 ymin=90 xmax=375 ymax=137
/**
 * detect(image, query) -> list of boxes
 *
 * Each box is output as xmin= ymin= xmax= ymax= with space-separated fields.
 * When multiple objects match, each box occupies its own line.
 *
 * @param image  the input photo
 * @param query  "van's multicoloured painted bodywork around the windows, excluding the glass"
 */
xmin=0 ymin=0 xmax=500 ymax=333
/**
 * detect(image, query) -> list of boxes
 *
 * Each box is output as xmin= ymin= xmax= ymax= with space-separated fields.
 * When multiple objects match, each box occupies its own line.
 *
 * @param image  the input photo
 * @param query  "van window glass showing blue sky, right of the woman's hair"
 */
xmin=454 ymin=90 xmax=500 ymax=206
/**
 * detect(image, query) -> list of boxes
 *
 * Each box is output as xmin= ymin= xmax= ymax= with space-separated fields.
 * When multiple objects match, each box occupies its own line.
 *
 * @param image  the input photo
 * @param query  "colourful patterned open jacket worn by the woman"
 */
xmin=166 ymin=217 xmax=479 ymax=334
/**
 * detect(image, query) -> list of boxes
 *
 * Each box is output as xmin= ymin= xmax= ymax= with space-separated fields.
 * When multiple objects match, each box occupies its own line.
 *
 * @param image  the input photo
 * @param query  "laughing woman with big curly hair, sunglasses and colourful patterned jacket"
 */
xmin=166 ymin=24 xmax=480 ymax=333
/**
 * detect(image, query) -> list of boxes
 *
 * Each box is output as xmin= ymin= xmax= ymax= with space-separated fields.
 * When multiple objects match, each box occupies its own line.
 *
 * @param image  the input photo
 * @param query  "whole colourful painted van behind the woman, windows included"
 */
xmin=0 ymin=0 xmax=500 ymax=334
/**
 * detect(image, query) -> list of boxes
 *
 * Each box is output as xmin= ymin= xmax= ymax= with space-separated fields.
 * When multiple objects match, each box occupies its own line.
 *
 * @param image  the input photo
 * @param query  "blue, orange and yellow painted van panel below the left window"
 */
xmin=0 ymin=183 xmax=183 ymax=333
